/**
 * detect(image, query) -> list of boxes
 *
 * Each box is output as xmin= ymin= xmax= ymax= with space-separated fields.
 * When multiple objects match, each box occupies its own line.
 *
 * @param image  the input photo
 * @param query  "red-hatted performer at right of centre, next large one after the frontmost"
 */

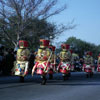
xmin=57 ymin=44 xmax=71 ymax=80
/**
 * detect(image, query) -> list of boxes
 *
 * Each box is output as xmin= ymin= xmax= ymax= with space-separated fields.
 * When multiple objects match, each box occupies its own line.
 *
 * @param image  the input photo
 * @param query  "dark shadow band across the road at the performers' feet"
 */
xmin=0 ymin=73 xmax=100 ymax=89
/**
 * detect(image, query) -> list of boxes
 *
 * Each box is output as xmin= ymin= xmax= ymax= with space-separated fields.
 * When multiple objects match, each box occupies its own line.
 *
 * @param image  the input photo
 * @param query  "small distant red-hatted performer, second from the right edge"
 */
xmin=83 ymin=51 xmax=94 ymax=77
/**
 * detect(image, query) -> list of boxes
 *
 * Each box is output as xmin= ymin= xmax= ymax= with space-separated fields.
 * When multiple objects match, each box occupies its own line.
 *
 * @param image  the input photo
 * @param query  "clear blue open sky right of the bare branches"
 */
xmin=50 ymin=0 xmax=100 ymax=45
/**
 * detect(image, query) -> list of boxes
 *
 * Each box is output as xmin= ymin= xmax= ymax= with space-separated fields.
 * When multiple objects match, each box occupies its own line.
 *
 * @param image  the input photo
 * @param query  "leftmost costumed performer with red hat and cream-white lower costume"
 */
xmin=12 ymin=40 xmax=30 ymax=82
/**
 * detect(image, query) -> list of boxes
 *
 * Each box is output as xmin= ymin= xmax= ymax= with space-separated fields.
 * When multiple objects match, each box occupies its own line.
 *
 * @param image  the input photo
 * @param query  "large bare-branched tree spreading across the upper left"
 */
xmin=0 ymin=0 xmax=73 ymax=47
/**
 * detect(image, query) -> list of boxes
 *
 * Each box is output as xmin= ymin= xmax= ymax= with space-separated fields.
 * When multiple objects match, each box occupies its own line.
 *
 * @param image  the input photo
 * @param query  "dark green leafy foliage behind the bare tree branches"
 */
xmin=0 ymin=16 xmax=56 ymax=49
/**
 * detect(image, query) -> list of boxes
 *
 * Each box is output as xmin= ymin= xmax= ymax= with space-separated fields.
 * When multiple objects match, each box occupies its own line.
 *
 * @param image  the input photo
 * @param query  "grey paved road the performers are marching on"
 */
xmin=0 ymin=72 xmax=100 ymax=100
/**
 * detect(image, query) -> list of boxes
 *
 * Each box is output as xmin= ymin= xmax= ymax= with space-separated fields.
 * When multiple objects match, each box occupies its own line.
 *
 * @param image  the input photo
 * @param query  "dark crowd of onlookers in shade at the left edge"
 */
xmin=0 ymin=46 xmax=16 ymax=75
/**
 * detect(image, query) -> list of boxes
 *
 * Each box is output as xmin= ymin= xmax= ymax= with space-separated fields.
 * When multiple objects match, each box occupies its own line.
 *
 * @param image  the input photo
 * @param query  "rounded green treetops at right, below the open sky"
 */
xmin=66 ymin=37 xmax=100 ymax=58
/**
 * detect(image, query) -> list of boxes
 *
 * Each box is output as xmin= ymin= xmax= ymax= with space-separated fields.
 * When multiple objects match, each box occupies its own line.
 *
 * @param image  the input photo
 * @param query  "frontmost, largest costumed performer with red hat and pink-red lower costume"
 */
xmin=32 ymin=39 xmax=51 ymax=85
